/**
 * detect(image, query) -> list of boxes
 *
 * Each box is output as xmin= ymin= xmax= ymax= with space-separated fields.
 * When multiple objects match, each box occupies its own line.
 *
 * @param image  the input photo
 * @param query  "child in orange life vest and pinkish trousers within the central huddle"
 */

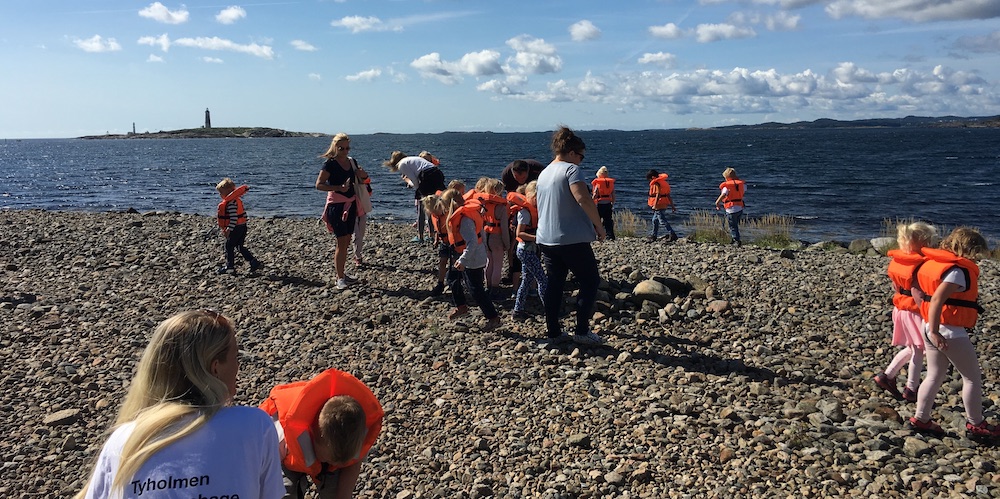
xmin=474 ymin=177 xmax=510 ymax=294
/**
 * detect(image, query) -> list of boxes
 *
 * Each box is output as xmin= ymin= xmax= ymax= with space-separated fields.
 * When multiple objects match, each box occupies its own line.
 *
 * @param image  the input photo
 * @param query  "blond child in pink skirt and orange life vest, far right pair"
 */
xmin=874 ymin=222 xmax=937 ymax=402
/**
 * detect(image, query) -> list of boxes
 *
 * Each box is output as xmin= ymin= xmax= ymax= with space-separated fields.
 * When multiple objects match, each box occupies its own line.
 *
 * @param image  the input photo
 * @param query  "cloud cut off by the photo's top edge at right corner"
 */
xmin=826 ymin=0 xmax=1000 ymax=22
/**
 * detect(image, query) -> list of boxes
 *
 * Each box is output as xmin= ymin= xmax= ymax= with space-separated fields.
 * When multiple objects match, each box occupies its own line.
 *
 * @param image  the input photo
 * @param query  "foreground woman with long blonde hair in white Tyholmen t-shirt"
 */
xmin=77 ymin=310 xmax=285 ymax=498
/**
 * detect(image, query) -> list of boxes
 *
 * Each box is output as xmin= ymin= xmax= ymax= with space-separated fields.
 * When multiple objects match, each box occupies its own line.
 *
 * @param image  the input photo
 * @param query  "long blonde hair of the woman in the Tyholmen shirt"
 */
xmin=77 ymin=310 xmax=234 ymax=498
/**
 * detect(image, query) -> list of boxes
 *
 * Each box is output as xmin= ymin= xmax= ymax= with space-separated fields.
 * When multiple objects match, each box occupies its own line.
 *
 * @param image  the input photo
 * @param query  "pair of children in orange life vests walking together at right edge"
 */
xmin=873 ymin=222 xmax=1000 ymax=438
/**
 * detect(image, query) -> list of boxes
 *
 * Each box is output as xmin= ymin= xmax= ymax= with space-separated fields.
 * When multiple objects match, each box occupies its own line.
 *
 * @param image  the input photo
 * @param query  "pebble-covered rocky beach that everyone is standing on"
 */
xmin=0 ymin=211 xmax=1000 ymax=499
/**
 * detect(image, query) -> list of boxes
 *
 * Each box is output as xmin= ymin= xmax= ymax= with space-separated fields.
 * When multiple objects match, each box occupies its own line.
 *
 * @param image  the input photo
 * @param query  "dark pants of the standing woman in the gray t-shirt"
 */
xmin=538 ymin=243 xmax=601 ymax=338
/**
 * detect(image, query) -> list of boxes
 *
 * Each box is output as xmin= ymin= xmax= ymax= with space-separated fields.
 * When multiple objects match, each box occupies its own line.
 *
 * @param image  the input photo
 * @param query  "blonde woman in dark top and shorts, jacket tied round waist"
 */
xmin=316 ymin=133 xmax=368 ymax=289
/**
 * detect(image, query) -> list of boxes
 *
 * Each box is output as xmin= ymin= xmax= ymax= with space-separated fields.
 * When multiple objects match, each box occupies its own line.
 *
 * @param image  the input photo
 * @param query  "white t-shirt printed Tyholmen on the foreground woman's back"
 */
xmin=84 ymin=406 xmax=285 ymax=499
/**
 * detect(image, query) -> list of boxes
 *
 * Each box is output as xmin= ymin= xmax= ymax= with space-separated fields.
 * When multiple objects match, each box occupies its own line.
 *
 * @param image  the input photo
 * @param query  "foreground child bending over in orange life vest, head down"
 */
xmin=260 ymin=369 xmax=384 ymax=499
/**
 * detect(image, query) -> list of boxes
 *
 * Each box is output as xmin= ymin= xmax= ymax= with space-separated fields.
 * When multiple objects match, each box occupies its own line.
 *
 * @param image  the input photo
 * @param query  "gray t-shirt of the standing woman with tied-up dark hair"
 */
xmin=535 ymin=161 xmax=597 ymax=246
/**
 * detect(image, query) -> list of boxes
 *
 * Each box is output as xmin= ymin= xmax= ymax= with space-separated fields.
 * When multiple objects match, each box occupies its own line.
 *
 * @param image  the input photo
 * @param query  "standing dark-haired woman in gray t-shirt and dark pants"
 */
xmin=535 ymin=127 xmax=605 ymax=345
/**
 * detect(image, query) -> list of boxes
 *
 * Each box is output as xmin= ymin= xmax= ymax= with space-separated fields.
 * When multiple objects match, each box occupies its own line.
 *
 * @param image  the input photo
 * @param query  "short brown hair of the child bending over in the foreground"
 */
xmin=318 ymin=395 xmax=368 ymax=464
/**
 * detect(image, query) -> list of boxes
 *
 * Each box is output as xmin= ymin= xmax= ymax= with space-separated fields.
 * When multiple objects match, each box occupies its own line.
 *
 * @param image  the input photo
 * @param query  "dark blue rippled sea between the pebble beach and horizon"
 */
xmin=0 ymin=128 xmax=1000 ymax=245
